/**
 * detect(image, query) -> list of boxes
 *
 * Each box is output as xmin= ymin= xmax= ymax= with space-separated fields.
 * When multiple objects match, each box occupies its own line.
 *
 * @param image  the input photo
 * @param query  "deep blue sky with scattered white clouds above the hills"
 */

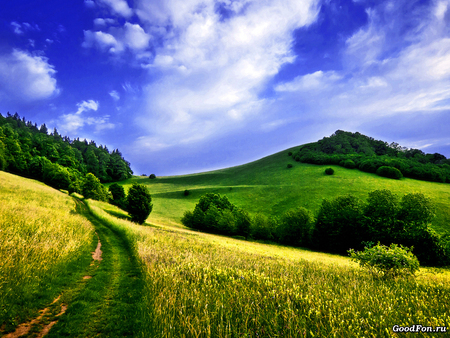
xmin=0 ymin=0 xmax=450 ymax=176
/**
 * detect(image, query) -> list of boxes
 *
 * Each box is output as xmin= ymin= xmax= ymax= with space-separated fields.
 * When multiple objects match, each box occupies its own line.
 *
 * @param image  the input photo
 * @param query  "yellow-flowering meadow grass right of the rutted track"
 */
xmin=92 ymin=202 xmax=450 ymax=337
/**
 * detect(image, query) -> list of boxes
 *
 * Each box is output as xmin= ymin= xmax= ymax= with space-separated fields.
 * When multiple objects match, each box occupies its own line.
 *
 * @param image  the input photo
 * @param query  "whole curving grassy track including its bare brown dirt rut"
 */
xmin=4 ymin=201 xmax=143 ymax=338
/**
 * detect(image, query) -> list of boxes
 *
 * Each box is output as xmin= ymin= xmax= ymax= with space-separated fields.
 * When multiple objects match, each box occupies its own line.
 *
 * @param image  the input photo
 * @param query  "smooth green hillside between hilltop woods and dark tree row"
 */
xmin=118 ymin=149 xmax=450 ymax=231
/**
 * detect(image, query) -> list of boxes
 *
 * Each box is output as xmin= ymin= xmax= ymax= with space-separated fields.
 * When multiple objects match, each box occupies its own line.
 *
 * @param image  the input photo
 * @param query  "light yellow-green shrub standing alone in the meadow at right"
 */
xmin=348 ymin=243 xmax=420 ymax=278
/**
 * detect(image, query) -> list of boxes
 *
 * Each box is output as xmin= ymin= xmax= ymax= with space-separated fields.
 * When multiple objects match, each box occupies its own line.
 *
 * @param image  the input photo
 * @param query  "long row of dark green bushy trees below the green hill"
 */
xmin=181 ymin=190 xmax=450 ymax=266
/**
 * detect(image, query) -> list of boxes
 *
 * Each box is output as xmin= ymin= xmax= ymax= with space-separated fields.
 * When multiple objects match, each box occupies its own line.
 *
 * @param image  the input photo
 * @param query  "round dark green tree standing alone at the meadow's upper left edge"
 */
xmin=126 ymin=183 xmax=153 ymax=224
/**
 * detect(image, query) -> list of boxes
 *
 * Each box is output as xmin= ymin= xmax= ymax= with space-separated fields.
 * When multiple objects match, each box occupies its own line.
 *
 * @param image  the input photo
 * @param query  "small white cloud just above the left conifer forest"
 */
xmin=58 ymin=100 xmax=114 ymax=133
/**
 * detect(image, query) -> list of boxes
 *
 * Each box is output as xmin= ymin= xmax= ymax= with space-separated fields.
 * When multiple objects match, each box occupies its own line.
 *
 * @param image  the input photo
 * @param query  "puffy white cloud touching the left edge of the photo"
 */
xmin=0 ymin=49 xmax=59 ymax=101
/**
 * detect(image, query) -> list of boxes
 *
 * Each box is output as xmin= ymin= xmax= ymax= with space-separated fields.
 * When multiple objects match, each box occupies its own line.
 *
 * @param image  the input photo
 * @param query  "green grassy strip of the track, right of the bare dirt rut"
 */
xmin=48 ymin=199 xmax=143 ymax=337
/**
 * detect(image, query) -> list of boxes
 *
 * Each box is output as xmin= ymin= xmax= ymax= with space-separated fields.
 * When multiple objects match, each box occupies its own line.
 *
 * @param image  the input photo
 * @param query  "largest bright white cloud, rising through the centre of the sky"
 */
xmin=130 ymin=0 xmax=317 ymax=151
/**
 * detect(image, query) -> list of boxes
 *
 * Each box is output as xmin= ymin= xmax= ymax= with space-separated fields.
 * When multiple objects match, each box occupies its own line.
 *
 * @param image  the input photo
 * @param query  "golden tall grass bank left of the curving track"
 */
xmin=0 ymin=172 xmax=94 ymax=330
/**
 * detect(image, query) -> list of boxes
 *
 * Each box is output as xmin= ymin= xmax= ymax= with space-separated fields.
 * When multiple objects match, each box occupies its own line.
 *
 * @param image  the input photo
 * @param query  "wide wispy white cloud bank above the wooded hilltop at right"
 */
xmin=275 ymin=1 xmax=450 ymax=139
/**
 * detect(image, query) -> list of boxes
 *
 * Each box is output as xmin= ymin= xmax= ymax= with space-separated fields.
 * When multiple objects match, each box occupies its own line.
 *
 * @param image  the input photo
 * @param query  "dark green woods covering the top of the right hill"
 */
xmin=290 ymin=130 xmax=450 ymax=183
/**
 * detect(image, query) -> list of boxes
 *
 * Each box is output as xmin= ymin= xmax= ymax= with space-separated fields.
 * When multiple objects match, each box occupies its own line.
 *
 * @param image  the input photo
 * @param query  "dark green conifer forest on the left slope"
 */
xmin=0 ymin=113 xmax=133 ymax=193
